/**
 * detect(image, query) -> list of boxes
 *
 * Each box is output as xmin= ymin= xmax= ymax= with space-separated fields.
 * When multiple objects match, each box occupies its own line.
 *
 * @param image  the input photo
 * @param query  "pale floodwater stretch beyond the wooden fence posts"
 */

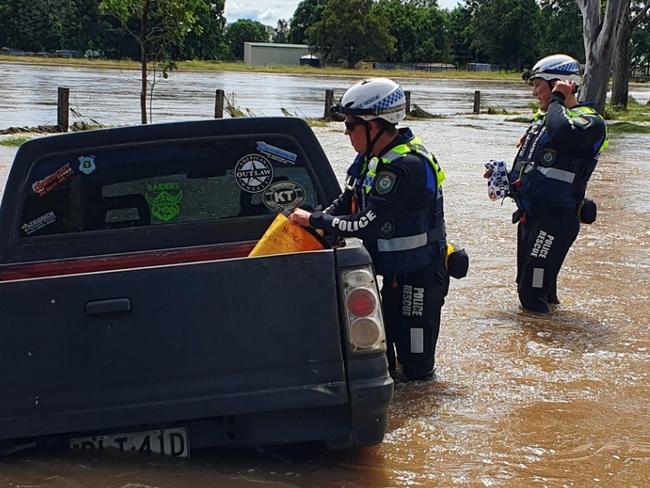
xmin=0 ymin=63 xmax=650 ymax=129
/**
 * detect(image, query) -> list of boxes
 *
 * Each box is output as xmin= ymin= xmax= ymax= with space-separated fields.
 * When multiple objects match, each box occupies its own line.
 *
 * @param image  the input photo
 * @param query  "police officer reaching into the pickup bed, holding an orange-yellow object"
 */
xmin=290 ymin=78 xmax=467 ymax=380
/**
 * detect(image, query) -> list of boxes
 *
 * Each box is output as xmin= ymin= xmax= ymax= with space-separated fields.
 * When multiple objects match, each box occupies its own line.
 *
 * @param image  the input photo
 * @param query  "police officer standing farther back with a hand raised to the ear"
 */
xmin=486 ymin=54 xmax=608 ymax=313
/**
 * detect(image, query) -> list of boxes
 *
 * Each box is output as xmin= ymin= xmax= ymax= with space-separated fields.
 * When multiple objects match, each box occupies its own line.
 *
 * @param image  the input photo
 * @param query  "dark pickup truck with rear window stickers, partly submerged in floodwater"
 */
xmin=0 ymin=118 xmax=393 ymax=456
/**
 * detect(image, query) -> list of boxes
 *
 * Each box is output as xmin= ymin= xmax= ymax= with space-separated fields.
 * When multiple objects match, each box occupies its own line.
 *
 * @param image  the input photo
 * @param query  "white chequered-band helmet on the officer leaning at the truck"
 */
xmin=332 ymin=78 xmax=406 ymax=124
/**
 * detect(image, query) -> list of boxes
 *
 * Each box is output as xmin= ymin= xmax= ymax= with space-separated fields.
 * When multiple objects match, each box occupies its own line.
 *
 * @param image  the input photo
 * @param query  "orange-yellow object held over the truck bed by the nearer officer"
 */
xmin=248 ymin=214 xmax=324 ymax=257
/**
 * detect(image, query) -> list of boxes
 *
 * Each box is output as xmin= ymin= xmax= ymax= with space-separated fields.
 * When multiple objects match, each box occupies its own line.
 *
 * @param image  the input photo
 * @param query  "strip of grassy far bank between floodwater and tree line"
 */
xmin=0 ymin=55 xmax=521 ymax=82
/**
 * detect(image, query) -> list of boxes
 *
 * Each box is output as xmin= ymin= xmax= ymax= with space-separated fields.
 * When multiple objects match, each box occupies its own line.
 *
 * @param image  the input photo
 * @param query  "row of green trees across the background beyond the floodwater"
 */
xmin=0 ymin=0 xmax=650 ymax=118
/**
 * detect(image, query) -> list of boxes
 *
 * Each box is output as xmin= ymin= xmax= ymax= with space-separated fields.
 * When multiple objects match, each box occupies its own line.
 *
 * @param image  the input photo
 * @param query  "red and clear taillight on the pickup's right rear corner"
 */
xmin=341 ymin=267 xmax=386 ymax=353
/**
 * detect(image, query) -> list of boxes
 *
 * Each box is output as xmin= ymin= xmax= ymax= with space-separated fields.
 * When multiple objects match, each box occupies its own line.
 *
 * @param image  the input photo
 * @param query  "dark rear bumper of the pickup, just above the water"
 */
xmin=0 ymin=377 xmax=393 ymax=455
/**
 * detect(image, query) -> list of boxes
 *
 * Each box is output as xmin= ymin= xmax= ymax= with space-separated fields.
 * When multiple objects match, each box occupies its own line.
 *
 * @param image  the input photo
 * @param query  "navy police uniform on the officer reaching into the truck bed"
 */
xmin=310 ymin=129 xmax=449 ymax=379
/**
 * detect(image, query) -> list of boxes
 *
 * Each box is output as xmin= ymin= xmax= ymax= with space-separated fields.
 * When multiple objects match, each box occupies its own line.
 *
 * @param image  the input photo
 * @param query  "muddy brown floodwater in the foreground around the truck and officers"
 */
xmin=0 ymin=66 xmax=650 ymax=488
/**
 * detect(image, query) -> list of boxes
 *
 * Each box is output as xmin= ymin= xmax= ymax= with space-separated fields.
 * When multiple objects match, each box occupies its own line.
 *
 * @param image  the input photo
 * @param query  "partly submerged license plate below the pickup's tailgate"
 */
xmin=70 ymin=427 xmax=190 ymax=458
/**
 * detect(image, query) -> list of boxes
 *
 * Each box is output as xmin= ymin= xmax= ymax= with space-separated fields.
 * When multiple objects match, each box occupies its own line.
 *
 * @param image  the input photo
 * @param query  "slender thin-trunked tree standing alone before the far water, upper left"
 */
xmin=99 ymin=0 xmax=203 ymax=124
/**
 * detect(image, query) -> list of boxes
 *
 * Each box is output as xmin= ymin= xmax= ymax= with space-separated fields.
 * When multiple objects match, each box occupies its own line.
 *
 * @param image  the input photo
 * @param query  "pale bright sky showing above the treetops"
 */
xmin=226 ymin=0 xmax=459 ymax=27
